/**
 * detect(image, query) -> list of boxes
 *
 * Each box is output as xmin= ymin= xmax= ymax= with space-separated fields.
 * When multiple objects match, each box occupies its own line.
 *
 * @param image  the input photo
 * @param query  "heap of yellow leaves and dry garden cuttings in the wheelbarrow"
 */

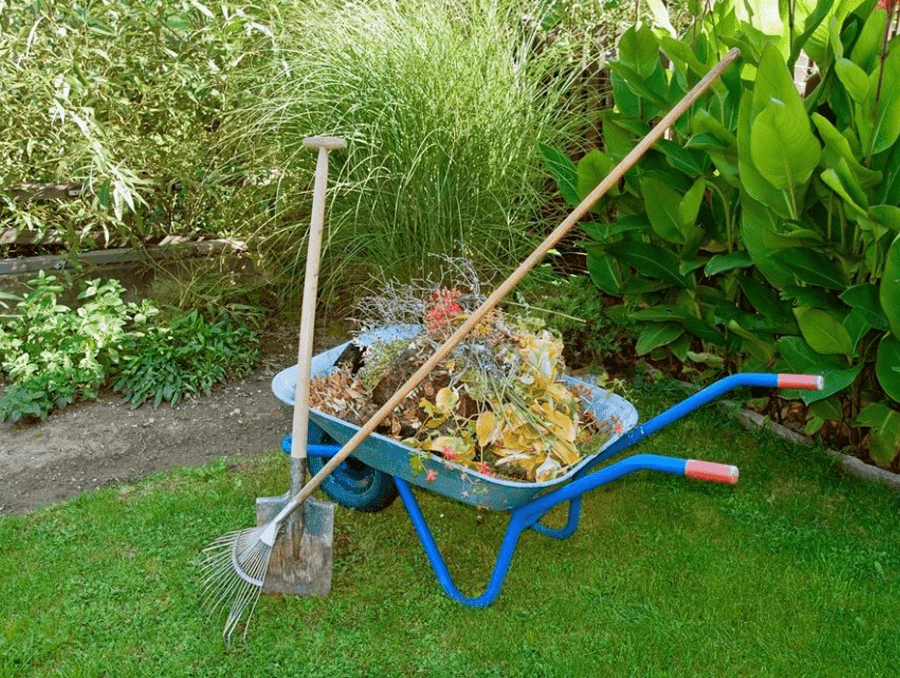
xmin=310 ymin=266 xmax=618 ymax=482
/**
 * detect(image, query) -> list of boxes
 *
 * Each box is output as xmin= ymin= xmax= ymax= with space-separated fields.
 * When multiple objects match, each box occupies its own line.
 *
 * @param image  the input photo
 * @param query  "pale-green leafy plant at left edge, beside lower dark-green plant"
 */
xmin=0 ymin=274 xmax=156 ymax=421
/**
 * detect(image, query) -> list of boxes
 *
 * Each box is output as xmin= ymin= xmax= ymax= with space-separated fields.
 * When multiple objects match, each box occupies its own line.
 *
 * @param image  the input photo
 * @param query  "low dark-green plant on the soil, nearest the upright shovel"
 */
xmin=113 ymin=311 xmax=259 ymax=407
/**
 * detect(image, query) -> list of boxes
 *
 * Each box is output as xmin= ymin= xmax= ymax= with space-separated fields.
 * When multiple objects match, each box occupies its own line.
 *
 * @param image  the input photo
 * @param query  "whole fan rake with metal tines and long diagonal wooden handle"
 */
xmin=200 ymin=48 xmax=740 ymax=634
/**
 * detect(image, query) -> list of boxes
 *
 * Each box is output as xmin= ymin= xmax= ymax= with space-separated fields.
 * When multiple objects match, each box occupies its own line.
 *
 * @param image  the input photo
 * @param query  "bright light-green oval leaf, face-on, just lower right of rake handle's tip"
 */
xmin=750 ymin=101 xmax=822 ymax=195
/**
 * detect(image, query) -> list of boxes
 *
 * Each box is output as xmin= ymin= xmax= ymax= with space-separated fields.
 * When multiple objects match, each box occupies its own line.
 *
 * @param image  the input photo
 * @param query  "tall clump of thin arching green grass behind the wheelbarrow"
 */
xmin=222 ymin=0 xmax=585 ymax=306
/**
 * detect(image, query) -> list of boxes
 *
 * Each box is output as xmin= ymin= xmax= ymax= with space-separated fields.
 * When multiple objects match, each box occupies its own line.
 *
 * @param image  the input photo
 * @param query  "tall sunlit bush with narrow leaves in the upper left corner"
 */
xmin=0 ymin=0 xmax=278 ymax=245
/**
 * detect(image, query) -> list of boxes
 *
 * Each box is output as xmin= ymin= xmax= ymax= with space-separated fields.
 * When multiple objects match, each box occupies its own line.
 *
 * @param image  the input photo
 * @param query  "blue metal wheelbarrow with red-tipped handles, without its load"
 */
xmin=272 ymin=326 xmax=824 ymax=607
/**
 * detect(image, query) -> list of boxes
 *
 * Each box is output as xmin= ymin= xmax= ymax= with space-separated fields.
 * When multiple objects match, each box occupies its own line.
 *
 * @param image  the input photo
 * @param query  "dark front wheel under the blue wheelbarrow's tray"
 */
xmin=281 ymin=432 xmax=398 ymax=513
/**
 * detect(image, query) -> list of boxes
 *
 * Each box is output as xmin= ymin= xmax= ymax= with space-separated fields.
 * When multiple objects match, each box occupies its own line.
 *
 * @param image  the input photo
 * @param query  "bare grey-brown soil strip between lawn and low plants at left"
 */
xmin=0 ymin=330 xmax=338 ymax=515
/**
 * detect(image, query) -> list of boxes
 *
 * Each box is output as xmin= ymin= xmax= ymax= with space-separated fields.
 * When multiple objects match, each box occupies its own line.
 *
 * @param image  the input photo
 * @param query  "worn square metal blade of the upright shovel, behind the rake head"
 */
xmin=256 ymin=492 xmax=334 ymax=596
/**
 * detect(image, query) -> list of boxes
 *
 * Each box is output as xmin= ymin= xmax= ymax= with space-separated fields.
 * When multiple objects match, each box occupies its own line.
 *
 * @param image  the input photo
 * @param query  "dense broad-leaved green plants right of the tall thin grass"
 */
xmin=545 ymin=0 xmax=900 ymax=465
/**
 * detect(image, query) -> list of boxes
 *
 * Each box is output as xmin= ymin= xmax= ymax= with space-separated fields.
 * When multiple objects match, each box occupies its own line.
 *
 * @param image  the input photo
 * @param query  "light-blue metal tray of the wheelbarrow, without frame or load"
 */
xmin=272 ymin=325 xmax=638 ymax=510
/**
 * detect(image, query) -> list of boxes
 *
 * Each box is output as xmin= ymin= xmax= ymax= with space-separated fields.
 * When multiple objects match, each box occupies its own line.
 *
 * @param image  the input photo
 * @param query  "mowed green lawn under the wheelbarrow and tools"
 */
xmin=0 ymin=385 xmax=900 ymax=678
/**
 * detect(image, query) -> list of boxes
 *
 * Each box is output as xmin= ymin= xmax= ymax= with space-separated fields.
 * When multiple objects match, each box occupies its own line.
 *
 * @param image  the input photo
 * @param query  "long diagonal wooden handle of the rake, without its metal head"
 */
xmin=273 ymin=48 xmax=740 ymax=524
